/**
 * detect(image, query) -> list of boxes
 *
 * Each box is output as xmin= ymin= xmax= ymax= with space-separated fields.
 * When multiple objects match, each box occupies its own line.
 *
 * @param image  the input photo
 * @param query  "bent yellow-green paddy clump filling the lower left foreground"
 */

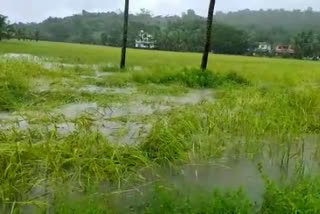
xmin=0 ymin=126 xmax=152 ymax=211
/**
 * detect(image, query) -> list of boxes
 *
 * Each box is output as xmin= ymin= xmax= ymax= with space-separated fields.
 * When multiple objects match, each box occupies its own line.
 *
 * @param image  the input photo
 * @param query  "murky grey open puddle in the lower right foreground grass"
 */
xmin=160 ymin=159 xmax=264 ymax=203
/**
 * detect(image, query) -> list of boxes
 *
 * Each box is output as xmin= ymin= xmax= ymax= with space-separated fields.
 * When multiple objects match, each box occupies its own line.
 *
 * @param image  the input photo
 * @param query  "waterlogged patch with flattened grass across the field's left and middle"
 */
xmin=0 ymin=54 xmax=215 ymax=144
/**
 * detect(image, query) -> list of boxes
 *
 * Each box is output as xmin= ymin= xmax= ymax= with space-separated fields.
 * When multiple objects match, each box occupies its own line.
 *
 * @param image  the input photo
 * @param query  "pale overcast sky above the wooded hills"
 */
xmin=0 ymin=0 xmax=320 ymax=22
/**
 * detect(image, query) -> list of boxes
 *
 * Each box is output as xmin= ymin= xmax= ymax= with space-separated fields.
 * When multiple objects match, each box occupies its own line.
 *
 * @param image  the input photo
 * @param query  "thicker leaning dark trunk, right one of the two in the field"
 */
xmin=201 ymin=0 xmax=216 ymax=70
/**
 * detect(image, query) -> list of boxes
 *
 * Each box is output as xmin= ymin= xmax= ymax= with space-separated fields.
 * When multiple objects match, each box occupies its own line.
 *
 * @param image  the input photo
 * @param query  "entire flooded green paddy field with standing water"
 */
xmin=0 ymin=42 xmax=320 ymax=213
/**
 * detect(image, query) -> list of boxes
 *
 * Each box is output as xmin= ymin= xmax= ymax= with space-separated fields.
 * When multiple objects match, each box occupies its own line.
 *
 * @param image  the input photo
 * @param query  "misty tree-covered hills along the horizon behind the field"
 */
xmin=16 ymin=8 xmax=320 ymax=51
